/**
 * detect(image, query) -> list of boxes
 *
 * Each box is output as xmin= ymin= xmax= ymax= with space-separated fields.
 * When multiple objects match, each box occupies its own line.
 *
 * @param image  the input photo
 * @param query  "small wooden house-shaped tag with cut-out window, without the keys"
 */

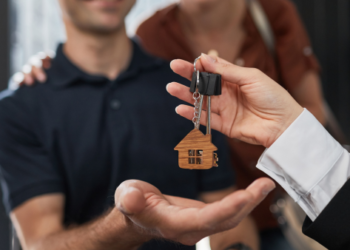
xmin=175 ymin=129 xmax=218 ymax=169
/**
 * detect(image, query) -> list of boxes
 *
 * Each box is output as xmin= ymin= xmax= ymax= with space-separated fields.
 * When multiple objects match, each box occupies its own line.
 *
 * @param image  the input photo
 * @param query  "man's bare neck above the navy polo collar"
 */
xmin=63 ymin=23 xmax=132 ymax=80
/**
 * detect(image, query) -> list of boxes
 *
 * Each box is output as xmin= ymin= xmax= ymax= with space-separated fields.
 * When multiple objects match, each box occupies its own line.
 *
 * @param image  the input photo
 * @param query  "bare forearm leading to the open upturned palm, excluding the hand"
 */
xmin=29 ymin=209 xmax=150 ymax=250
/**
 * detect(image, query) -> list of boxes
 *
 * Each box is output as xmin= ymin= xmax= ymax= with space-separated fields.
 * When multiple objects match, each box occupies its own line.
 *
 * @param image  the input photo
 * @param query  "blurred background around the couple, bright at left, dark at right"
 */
xmin=0 ymin=0 xmax=350 ymax=250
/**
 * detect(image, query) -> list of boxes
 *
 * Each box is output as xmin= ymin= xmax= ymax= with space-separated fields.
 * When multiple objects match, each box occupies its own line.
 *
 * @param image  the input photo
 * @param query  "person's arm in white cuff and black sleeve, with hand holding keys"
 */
xmin=167 ymin=55 xmax=350 ymax=250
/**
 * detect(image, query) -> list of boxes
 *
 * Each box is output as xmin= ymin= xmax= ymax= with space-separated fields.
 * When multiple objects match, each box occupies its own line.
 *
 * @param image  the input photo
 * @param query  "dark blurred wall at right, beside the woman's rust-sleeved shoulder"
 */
xmin=293 ymin=0 xmax=350 ymax=140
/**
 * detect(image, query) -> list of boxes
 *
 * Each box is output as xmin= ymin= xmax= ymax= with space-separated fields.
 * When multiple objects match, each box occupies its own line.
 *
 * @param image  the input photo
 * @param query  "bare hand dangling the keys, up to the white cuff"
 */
xmin=167 ymin=54 xmax=303 ymax=147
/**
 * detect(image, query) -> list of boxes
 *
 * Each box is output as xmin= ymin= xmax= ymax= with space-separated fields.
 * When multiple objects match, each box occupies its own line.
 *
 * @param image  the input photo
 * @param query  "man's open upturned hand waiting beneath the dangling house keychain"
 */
xmin=115 ymin=178 xmax=275 ymax=245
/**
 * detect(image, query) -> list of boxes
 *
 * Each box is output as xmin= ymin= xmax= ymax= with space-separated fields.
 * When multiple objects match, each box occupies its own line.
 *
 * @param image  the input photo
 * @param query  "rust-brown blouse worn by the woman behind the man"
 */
xmin=136 ymin=0 xmax=319 ymax=229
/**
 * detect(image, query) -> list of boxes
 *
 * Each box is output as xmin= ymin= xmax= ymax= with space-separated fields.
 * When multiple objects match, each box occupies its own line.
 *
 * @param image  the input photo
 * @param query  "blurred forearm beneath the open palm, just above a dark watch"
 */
xmin=210 ymin=217 xmax=259 ymax=250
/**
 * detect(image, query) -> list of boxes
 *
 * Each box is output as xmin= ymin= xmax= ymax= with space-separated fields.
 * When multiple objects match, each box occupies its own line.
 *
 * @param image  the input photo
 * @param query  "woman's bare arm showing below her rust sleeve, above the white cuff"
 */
xmin=291 ymin=71 xmax=326 ymax=125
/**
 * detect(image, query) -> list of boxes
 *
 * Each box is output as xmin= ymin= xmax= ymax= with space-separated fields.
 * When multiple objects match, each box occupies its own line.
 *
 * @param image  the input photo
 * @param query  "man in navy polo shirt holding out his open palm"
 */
xmin=0 ymin=0 xmax=274 ymax=250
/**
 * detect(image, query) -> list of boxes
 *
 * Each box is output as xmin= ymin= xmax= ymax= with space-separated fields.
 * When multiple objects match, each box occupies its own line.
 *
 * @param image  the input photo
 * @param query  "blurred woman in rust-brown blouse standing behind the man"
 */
xmin=137 ymin=0 xmax=325 ymax=250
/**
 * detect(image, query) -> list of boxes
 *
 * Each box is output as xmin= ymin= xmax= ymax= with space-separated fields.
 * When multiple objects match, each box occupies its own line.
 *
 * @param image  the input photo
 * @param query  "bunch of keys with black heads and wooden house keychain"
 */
xmin=175 ymin=57 xmax=221 ymax=169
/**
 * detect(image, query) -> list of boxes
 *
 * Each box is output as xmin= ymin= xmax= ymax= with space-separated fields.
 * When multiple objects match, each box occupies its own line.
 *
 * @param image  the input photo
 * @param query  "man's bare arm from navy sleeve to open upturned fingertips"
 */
xmin=11 ymin=179 xmax=274 ymax=250
